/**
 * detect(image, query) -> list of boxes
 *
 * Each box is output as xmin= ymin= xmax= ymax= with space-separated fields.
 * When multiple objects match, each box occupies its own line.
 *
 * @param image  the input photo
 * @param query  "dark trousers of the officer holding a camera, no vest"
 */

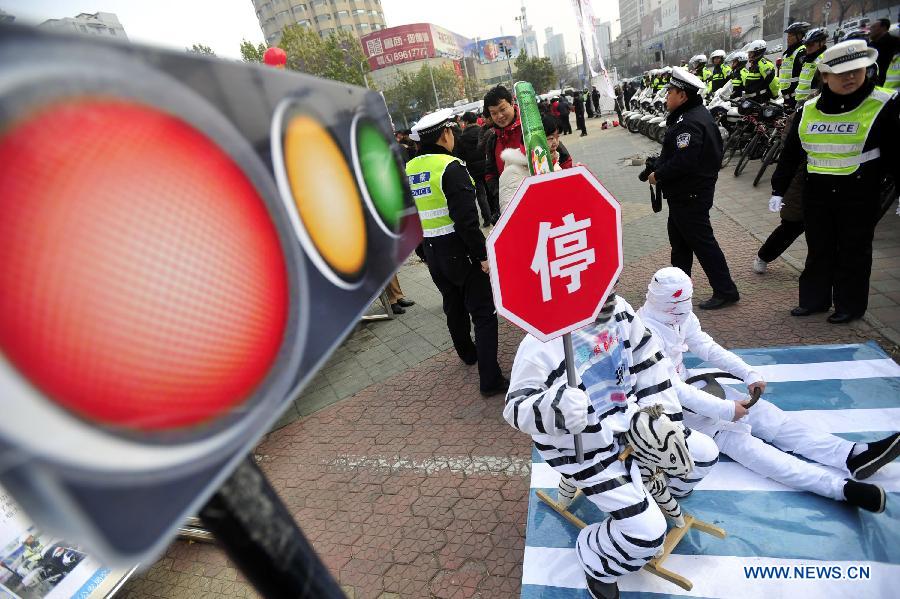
xmin=668 ymin=193 xmax=738 ymax=299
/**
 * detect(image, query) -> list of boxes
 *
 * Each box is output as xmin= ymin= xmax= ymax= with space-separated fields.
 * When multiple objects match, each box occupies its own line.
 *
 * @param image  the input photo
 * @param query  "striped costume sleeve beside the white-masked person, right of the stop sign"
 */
xmin=629 ymin=314 xmax=684 ymax=421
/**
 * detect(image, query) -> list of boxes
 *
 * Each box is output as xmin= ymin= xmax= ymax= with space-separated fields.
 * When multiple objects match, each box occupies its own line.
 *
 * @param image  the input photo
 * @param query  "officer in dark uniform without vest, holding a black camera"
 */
xmin=649 ymin=67 xmax=740 ymax=310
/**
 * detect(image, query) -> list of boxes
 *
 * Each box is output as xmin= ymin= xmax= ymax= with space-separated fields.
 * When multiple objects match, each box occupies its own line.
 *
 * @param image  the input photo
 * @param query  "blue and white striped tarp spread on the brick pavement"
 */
xmin=522 ymin=343 xmax=900 ymax=599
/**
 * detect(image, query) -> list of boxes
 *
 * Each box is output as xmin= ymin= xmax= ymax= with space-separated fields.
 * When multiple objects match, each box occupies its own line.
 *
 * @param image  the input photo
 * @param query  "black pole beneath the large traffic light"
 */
xmin=200 ymin=458 xmax=344 ymax=599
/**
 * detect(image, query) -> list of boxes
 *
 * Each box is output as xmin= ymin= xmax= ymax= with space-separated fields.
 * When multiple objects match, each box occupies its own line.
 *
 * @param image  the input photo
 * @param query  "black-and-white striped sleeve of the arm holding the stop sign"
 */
xmin=503 ymin=343 xmax=569 ymax=436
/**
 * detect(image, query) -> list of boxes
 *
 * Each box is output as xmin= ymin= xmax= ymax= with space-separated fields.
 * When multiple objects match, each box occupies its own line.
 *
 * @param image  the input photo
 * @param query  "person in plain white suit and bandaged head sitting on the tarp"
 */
xmin=638 ymin=266 xmax=900 ymax=512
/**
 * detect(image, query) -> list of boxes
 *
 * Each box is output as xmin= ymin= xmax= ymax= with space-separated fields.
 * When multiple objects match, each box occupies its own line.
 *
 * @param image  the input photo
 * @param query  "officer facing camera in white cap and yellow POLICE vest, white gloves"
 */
xmin=772 ymin=40 xmax=900 ymax=324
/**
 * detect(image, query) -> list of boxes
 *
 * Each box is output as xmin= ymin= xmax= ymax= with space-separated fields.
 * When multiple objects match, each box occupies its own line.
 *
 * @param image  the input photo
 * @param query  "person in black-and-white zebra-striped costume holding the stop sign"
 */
xmin=503 ymin=293 xmax=718 ymax=598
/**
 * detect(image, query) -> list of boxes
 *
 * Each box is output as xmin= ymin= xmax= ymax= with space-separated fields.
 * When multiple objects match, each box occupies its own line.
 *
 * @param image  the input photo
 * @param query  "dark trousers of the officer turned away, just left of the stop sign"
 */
xmin=423 ymin=239 xmax=503 ymax=391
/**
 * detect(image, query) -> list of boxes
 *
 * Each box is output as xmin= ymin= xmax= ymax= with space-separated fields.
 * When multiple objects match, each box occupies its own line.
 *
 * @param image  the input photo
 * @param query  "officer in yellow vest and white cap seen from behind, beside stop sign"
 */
xmin=406 ymin=108 xmax=509 ymax=396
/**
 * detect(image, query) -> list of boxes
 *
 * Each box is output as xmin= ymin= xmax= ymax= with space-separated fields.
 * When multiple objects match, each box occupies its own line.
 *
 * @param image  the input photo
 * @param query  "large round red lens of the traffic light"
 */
xmin=0 ymin=97 xmax=288 ymax=431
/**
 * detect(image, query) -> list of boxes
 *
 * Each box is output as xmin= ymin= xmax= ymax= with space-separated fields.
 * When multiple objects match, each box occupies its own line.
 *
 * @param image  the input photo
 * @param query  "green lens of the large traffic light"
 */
xmin=356 ymin=122 xmax=404 ymax=232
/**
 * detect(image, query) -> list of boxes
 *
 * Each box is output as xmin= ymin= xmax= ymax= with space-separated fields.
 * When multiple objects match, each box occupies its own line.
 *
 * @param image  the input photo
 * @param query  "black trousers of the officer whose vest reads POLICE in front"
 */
xmin=800 ymin=195 xmax=878 ymax=316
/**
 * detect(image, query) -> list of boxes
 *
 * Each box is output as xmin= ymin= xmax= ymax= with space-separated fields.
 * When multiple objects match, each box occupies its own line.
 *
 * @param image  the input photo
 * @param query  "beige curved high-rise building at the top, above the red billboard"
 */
xmin=253 ymin=0 xmax=384 ymax=45
